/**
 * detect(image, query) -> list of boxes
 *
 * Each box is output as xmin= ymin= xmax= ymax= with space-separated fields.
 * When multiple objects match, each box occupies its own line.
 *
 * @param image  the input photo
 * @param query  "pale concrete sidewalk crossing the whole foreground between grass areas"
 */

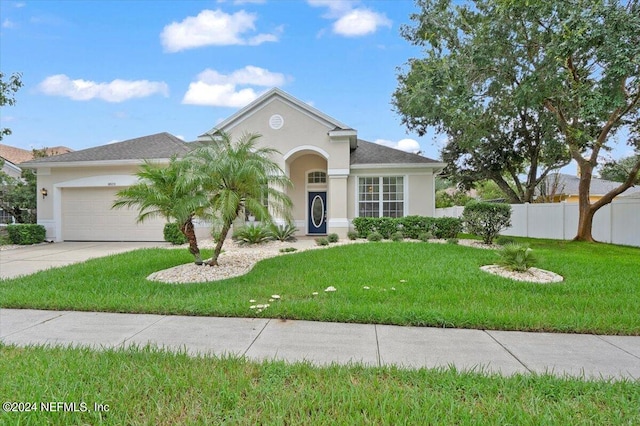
xmin=0 ymin=309 xmax=640 ymax=380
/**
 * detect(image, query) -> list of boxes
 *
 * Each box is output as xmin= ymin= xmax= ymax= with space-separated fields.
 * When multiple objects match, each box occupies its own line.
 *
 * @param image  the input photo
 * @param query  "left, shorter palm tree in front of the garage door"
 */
xmin=112 ymin=157 xmax=207 ymax=265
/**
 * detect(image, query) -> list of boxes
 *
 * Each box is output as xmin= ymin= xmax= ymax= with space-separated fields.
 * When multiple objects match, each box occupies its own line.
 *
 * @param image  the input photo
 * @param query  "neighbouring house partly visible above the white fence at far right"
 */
xmin=538 ymin=173 xmax=640 ymax=203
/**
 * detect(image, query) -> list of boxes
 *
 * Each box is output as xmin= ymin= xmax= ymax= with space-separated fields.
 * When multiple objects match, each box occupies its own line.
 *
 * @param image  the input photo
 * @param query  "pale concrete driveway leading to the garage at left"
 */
xmin=0 ymin=241 xmax=169 ymax=279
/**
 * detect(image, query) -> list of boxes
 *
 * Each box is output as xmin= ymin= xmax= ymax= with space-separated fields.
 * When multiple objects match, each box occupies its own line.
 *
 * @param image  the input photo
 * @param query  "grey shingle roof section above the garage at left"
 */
xmin=23 ymin=132 xmax=190 ymax=165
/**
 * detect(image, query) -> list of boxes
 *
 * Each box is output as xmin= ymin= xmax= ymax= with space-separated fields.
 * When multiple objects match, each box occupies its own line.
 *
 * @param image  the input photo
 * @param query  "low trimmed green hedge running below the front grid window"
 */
xmin=353 ymin=216 xmax=462 ymax=240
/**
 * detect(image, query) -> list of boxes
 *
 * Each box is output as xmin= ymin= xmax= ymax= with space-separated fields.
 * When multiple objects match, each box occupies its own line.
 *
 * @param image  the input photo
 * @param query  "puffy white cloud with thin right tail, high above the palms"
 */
xmin=160 ymin=9 xmax=282 ymax=53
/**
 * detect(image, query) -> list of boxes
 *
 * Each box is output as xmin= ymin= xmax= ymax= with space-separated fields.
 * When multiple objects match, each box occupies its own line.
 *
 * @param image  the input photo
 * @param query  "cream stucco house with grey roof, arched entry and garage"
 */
xmin=22 ymin=89 xmax=445 ymax=241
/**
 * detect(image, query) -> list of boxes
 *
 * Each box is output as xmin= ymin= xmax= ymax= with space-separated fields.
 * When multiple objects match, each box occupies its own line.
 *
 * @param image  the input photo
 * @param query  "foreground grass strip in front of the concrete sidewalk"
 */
xmin=0 ymin=344 xmax=640 ymax=425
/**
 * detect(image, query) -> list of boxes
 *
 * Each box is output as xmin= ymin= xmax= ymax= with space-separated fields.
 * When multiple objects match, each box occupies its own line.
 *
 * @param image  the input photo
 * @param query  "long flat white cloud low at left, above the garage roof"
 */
xmin=38 ymin=74 xmax=169 ymax=102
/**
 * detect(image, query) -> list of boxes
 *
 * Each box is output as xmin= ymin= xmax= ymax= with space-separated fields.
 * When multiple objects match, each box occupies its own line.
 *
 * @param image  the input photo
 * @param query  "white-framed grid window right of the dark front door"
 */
xmin=358 ymin=176 xmax=404 ymax=217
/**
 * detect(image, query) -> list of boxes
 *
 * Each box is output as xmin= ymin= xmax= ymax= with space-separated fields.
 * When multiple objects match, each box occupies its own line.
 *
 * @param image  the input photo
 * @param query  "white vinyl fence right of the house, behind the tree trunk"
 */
xmin=436 ymin=198 xmax=640 ymax=247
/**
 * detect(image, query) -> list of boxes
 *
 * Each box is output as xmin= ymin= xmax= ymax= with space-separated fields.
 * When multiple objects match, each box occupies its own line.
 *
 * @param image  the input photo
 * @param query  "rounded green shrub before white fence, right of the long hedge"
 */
xmin=462 ymin=201 xmax=511 ymax=244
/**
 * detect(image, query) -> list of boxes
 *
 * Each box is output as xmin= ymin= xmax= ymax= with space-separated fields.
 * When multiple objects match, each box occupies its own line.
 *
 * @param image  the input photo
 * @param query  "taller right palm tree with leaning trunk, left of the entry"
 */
xmin=185 ymin=131 xmax=292 ymax=266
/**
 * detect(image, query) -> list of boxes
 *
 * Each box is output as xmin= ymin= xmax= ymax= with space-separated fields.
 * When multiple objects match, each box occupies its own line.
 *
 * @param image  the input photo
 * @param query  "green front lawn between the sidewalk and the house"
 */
xmin=0 ymin=239 xmax=640 ymax=335
